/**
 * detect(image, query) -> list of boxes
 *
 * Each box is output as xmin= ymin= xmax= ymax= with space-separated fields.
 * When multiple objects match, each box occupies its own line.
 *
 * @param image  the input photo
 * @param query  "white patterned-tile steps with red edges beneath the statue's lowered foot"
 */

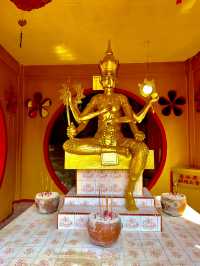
xmin=58 ymin=189 xmax=162 ymax=232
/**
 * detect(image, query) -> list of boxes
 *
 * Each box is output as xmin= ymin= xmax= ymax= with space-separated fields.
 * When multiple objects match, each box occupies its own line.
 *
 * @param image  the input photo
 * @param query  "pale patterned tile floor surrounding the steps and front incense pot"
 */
xmin=0 ymin=205 xmax=200 ymax=266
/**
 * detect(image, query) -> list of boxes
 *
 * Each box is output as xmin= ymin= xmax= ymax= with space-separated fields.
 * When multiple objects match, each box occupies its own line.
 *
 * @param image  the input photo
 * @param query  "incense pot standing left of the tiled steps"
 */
xmin=35 ymin=192 xmax=60 ymax=213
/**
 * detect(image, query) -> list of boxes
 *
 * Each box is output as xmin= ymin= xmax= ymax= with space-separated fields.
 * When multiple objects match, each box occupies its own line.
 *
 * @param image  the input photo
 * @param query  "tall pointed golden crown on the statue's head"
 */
xmin=99 ymin=41 xmax=119 ymax=76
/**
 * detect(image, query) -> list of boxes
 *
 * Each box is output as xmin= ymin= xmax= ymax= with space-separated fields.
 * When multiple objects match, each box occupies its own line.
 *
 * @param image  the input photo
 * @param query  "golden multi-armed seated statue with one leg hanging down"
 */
xmin=63 ymin=43 xmax=158 ymax=210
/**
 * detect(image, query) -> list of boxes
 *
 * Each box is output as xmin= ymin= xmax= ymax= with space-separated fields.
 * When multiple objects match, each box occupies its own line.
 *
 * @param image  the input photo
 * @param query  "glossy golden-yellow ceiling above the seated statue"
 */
xmin=0 ymin=0 xmax=200 ymax=65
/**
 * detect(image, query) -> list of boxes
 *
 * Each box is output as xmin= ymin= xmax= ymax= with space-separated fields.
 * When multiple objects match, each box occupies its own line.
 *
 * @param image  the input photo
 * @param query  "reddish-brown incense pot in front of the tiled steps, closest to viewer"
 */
xmin=87 ymin=212 xmax=122 ymax=247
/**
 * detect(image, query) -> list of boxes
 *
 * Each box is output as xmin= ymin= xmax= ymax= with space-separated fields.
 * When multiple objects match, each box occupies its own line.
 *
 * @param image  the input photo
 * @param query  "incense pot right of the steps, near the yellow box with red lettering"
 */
xmin=161 ymin=193 xmax=187 ymax=216
